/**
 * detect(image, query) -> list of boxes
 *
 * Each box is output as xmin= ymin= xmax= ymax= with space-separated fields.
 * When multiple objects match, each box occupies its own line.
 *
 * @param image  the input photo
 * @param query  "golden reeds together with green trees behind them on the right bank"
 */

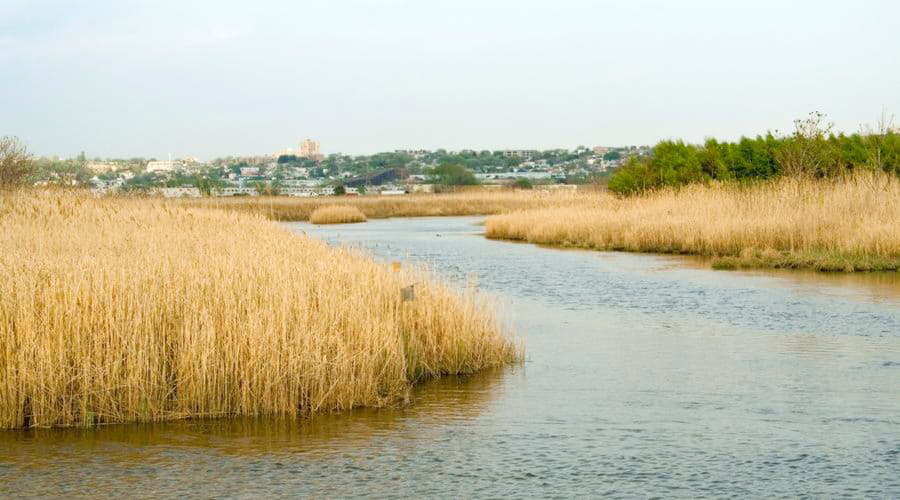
xmin=486 ymin=114 xmax=900 ymax=271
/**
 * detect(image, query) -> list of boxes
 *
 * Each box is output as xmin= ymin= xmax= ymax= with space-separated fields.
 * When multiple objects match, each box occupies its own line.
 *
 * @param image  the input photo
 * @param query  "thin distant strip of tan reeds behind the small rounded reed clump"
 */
xmin=179 ymin=189 xmax=590 ymax=221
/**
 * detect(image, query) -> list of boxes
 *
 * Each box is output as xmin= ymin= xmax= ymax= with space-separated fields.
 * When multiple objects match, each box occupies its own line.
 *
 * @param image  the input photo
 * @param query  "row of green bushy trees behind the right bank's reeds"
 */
xmin=609 ymin=113 xmax=900 ymax=195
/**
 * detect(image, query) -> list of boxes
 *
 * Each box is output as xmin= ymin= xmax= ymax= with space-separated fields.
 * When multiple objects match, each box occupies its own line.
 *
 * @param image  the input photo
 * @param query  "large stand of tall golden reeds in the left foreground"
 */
xmin=0 ymin=192 xmax=521 ymax=427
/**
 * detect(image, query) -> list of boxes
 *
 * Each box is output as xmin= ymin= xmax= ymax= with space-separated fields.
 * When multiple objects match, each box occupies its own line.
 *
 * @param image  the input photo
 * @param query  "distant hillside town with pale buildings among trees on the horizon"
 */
xmin=36 ymin=139 xmax=650 ymax=197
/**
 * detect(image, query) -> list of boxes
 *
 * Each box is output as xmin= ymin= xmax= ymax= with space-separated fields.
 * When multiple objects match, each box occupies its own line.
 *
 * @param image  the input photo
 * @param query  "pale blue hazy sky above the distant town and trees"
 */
xmin=0 ymin=0 xmax=900 ymax=159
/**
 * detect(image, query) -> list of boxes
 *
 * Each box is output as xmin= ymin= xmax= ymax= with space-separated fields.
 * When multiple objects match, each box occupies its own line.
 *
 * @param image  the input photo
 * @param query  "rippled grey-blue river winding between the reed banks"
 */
xmin=0 ymin=218 xmax=900 ymax=498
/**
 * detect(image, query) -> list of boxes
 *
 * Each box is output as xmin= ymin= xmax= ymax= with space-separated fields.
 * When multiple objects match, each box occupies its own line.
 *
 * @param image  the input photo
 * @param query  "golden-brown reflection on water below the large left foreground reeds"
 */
xmin=0 ymin=370 xmax=508 ymax=458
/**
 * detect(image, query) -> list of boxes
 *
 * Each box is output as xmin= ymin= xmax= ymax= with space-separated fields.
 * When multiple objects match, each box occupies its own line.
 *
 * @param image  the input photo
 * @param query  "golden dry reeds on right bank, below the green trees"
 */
xmin=486 ymin=173 xmax=900 ymax=271
